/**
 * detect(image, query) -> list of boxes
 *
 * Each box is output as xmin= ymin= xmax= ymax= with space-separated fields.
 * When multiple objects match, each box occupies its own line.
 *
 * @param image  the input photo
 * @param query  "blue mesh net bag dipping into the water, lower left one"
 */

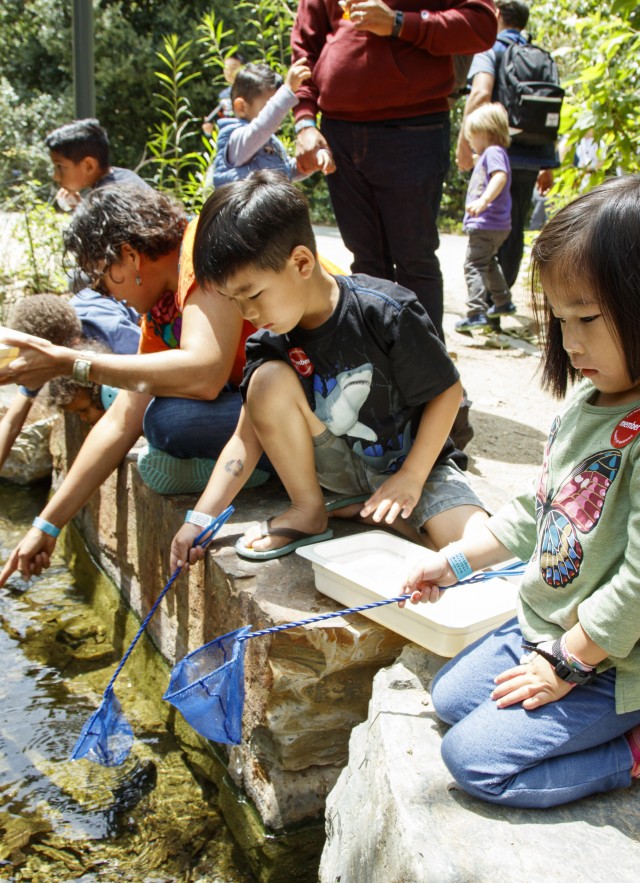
xmin=71 ymin=690 xmax=133 ymax=766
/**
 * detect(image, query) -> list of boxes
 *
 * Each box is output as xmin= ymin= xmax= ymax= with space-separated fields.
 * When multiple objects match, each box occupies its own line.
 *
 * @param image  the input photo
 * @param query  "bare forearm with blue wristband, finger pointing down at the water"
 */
xmin=0 ymin=392 xmax=150 ymax=586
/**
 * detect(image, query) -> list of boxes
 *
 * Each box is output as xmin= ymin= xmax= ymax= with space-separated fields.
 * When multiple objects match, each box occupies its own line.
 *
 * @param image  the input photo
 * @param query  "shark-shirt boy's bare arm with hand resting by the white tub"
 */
xmin=362 ymin=381 xmax=462 ymax=524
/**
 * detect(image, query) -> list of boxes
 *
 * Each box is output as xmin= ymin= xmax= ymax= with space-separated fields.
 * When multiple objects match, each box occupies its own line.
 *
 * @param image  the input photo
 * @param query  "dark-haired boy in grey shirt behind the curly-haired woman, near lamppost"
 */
xmin=44 ymin=119 xmax=149 ymax=211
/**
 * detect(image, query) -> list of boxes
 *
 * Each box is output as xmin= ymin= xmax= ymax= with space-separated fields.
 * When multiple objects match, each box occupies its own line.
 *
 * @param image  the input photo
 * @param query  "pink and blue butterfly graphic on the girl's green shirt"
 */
xmin=536 ymin=417 xmax=622 ymax=588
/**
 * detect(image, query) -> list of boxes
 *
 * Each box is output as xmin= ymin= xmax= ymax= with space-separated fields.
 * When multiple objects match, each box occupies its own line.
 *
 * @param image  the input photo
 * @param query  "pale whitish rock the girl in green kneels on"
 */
xmin=320 ymin=645 xmax=640 ymax=883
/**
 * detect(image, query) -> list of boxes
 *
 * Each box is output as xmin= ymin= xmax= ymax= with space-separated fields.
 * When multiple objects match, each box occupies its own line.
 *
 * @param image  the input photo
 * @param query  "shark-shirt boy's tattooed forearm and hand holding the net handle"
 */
xmin=171 ymin=407 xmax=262 ymax=571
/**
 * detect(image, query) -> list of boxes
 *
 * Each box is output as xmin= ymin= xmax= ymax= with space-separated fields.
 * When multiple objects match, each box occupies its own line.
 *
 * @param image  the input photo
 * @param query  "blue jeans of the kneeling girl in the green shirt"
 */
xmin=431 ymin=620 xmax=640 ymax=808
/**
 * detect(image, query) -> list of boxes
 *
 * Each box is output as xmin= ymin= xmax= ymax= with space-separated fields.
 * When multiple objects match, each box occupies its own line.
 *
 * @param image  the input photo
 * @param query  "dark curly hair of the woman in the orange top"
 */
xmin=63 ymin=186 xmax=187 ymax=278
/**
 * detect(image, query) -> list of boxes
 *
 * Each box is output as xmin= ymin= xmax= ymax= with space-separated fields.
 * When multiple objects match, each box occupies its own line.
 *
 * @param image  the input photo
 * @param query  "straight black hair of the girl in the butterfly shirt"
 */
xmin=531 ymin=175 xmax=640 ymax=397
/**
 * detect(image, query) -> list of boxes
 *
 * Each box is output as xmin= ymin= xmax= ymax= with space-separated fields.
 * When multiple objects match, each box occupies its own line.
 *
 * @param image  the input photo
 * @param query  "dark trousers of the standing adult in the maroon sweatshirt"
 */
xmin=322 ymin=115 xmax=449 ymax=337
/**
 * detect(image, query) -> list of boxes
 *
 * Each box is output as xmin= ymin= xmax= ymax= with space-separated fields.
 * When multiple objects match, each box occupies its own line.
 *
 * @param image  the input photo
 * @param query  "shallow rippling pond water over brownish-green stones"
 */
xmin=0 ymin=483 xmax=253 ymax=883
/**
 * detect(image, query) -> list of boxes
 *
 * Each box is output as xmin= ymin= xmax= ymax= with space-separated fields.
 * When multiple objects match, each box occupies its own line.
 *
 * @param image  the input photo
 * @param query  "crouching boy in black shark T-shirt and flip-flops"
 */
xmin=172 ymin=172 xmax=487 ymax=562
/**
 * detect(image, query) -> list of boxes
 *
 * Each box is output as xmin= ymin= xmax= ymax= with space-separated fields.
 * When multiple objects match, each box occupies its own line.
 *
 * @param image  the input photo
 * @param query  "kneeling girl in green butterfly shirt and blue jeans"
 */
xmin=405 ymin=176 xmax=640 ymax=807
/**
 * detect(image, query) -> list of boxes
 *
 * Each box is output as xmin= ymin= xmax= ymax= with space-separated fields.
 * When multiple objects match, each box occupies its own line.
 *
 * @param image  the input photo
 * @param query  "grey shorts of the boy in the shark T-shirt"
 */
xmin=313 ymin=429 xmax=486 ymax=530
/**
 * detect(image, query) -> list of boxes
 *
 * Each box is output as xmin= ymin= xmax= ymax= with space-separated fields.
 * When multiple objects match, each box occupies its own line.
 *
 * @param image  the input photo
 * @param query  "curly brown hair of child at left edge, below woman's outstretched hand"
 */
xmin=7 ymin=294 xmax=82 ymax=346
